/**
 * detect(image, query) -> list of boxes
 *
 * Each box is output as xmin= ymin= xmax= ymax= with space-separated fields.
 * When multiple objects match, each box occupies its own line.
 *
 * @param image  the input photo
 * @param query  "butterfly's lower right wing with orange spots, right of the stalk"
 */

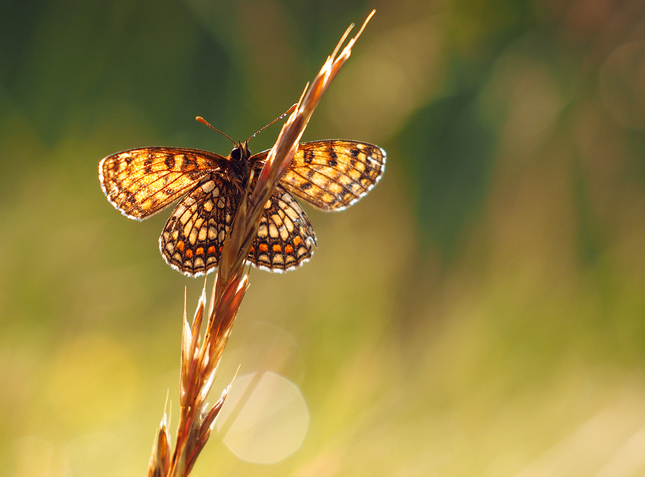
xmin=248 ymin=185 xmax=316 ymax=272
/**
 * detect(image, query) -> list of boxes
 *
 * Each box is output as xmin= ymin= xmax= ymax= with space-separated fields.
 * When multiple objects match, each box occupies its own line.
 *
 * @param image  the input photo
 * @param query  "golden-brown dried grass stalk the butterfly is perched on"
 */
xmin=148 ymin=11 xmax=375 ymax=477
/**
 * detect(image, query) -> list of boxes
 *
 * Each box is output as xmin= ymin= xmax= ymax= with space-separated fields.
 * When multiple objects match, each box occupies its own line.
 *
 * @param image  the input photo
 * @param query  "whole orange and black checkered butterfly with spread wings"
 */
xmin=99 ymin=118 xmax=386 ymax=277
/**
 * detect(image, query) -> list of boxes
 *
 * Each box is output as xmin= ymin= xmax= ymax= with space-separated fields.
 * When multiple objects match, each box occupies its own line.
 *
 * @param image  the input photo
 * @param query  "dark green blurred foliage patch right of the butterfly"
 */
xmin=401 ymin=92 xmax=493 ymax=257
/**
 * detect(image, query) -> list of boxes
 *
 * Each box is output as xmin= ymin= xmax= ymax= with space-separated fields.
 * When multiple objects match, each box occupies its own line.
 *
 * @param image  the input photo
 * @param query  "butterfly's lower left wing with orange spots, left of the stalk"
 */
xmin=159 ymin=174 xmax=239 ymax=276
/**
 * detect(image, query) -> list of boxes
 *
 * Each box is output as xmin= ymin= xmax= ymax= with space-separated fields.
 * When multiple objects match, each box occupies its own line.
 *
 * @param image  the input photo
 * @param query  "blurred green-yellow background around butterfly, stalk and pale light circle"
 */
xmin=0 ymin=0 xmax=645 ymax=477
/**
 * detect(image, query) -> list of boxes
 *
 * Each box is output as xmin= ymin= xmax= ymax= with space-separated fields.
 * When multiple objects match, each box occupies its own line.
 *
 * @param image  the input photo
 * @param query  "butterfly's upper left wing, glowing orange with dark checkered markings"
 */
xmin=99 ymin=147 xmax=228 ymax=220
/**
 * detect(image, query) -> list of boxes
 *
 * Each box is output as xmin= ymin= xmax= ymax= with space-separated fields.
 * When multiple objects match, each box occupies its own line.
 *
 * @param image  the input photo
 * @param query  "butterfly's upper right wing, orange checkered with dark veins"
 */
xmin=281 ymin=140 xmax=386 ymax=211
